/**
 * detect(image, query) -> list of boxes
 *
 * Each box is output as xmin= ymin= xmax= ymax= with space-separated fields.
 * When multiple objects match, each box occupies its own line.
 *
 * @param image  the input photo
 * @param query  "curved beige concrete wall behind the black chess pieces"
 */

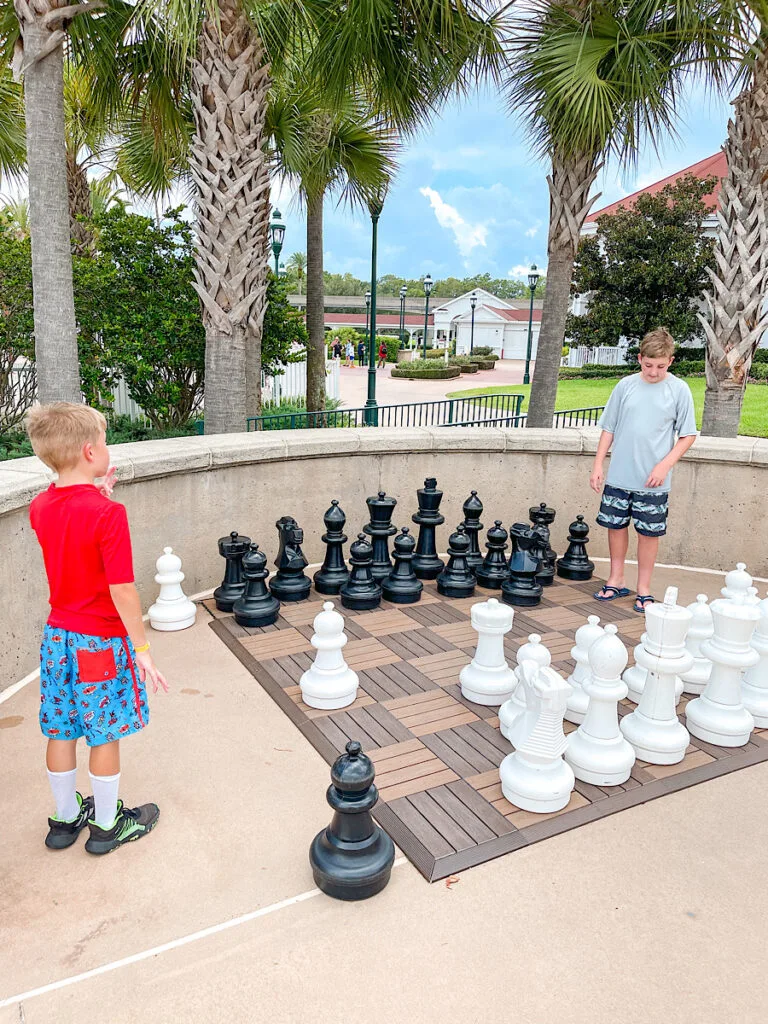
xmin=0 ymin=428 xmax=768 ymax=689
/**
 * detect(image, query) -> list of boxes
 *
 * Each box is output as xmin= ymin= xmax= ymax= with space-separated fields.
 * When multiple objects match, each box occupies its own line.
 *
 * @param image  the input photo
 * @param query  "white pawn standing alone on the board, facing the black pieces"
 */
xmin=299 ymin=601 xmax=358 ymax=710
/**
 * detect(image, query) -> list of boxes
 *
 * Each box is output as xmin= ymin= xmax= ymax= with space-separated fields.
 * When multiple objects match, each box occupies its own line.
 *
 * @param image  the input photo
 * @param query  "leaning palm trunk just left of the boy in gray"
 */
xmin=526 ymin=153 xmax=600 ymax=427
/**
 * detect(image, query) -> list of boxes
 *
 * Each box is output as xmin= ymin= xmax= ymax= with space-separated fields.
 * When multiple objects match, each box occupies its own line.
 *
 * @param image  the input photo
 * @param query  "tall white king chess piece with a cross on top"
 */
xmin=621 ymin=587 xmax=693 ymax=765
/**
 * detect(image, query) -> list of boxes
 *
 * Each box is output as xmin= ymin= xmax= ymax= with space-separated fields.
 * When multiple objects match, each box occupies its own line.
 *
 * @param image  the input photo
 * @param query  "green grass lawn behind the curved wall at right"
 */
xmin=446 ymin=377 xmax=768 ymax=437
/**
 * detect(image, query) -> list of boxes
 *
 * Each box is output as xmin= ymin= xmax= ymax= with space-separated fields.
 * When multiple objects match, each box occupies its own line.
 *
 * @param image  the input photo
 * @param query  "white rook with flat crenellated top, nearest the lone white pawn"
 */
xmin=459 ymin=597 xmax=517 ymax=706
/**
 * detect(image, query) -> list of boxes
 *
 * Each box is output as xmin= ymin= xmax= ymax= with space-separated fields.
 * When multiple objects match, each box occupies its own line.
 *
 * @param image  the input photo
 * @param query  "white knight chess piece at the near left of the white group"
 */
xmin=499 ymin=660 xmax=575 ymax=814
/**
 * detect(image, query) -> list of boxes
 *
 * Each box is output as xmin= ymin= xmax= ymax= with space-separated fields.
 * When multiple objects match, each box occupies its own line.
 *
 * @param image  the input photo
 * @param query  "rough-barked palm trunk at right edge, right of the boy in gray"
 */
xmin=699 ymin=52 xmax=768 ymax=437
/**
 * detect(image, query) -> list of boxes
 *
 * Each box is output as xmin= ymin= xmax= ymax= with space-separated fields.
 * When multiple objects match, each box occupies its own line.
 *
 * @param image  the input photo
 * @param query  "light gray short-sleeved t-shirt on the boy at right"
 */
xmin=599 ymin=374 xmax=697 ymax=493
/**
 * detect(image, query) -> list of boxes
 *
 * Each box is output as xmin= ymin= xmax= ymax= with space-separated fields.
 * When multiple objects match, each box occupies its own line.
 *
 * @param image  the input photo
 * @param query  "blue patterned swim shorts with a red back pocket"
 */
xmin=40 ymin=626 xmax=150 ymax=746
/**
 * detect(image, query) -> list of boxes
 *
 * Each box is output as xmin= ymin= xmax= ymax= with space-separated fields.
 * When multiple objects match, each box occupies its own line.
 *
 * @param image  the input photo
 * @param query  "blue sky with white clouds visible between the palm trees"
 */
xmin=274 ymin=80 xmax=730 ymax=279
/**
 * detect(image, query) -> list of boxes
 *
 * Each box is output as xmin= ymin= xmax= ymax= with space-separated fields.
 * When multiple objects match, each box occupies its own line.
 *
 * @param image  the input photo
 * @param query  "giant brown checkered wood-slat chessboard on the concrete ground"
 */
xmin=206 ymin=580 xmax=768 ymax=881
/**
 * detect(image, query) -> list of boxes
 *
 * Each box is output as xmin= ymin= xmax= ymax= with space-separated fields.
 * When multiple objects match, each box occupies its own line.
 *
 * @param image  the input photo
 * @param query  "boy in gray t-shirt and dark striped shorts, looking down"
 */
xmin=590 ymin=328 xmax=696 ymax=612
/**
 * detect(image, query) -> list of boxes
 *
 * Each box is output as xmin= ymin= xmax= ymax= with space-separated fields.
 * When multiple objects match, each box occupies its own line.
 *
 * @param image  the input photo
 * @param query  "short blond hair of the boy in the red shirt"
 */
xmin=24 ymin=401 xmax=106 ymax=473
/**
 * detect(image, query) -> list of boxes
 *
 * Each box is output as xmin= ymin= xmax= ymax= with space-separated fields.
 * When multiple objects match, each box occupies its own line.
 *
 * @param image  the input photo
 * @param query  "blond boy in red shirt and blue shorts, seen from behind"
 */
xmin=25 ymin=401 xmax=168 ymax=854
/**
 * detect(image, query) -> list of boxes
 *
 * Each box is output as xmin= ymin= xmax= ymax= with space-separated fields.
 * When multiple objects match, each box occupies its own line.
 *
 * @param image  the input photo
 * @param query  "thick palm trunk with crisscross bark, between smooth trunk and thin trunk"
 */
xmin=191 ymin=0 xmax=269 ymax=434
